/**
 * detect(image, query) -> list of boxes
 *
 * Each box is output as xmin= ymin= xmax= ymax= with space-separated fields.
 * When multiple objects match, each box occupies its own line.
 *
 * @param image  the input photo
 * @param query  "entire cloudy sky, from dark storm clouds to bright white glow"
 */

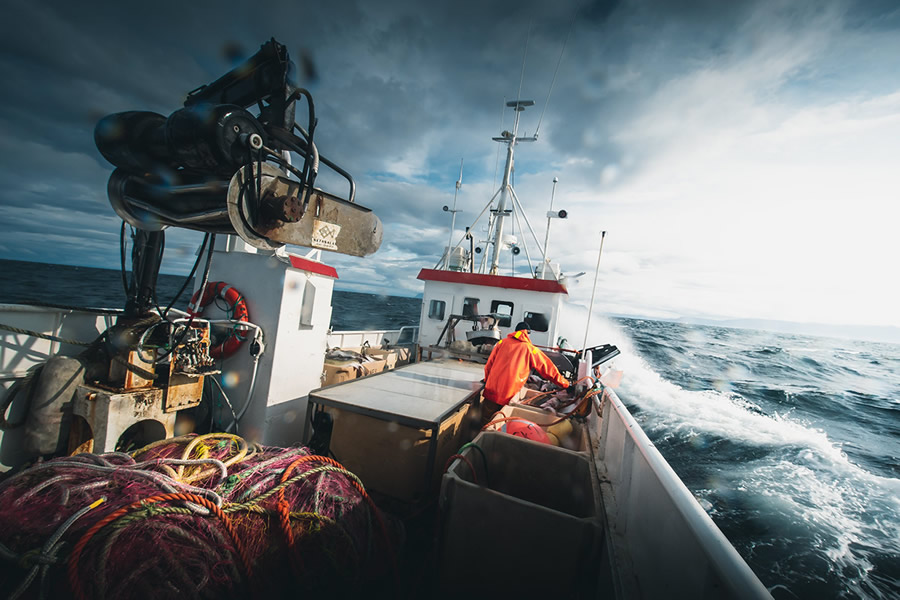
xmin=0 ymin=0 xmax=900 ymax=326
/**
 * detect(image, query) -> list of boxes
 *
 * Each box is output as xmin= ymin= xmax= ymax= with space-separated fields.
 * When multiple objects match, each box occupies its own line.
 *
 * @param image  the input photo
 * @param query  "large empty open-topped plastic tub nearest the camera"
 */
xmin=438 ymin=432 xmax=601 ymax=598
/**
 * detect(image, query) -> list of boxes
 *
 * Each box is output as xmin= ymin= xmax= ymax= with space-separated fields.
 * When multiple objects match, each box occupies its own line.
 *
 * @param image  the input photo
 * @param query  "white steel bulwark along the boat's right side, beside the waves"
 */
xmin=596 ymin=389 xmax=772 ymax=600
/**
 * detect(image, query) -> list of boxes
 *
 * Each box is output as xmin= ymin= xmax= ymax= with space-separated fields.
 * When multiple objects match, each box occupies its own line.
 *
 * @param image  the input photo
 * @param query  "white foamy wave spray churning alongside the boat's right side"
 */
xmin=562 ymin=304 xmax=900 ymax=598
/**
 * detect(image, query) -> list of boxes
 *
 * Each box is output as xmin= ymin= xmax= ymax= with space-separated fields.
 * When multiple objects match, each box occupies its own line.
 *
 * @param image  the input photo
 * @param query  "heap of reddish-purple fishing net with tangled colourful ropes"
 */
xmin=0 ymin=434 xmax=397 ymax=598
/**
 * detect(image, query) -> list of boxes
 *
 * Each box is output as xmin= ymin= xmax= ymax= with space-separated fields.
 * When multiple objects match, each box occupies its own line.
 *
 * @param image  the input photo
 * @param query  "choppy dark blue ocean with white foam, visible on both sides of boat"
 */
xmin=0 ymin=261 xmax=900 ymax=600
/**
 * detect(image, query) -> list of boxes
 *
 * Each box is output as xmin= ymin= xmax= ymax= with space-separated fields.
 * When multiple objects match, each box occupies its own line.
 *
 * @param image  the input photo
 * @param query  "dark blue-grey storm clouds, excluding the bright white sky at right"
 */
xmin=0 ymin=0 xmax=896 ymax=304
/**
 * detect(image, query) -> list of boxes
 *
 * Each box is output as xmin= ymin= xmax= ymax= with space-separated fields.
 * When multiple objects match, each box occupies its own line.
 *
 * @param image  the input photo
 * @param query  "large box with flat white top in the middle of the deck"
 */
xmin=306 ymin=358 xmax=484 ymax=506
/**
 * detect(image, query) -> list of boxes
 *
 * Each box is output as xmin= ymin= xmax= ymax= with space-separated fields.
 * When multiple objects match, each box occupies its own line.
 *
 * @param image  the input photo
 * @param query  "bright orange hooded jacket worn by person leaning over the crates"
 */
xmin=484 ymin=330 xmax=569 ymax=405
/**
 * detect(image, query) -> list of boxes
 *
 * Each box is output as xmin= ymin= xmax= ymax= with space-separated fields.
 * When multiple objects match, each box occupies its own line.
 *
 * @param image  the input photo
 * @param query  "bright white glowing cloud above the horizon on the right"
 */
xmin=560 ymin=86 xmax=900 ymax=325
